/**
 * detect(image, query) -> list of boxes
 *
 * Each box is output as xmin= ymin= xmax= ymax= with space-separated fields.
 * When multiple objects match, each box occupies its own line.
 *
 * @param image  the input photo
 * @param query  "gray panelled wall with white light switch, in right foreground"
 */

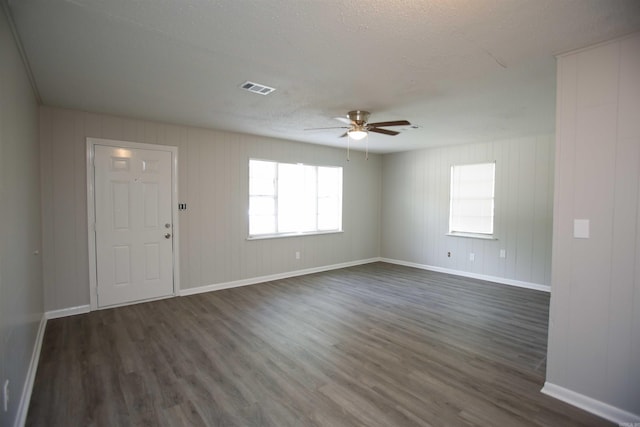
xmin=547 ymin=34 xmax=640 ymax=417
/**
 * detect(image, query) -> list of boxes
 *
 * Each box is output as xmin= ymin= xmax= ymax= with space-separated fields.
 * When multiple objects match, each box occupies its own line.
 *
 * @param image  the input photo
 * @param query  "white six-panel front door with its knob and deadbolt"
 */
xmin=94 ymin=145 xmax=174 ymax=307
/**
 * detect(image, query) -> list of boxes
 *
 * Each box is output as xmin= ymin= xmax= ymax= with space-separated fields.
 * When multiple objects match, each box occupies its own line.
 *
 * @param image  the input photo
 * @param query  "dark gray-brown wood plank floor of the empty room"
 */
xmin=27 ymin=263 xmax=608 ymax=427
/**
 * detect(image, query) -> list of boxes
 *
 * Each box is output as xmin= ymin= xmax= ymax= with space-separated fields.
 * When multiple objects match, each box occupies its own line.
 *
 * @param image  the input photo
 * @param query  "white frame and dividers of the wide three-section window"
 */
xmin=247 ymin=157 xmax=344 ymax=240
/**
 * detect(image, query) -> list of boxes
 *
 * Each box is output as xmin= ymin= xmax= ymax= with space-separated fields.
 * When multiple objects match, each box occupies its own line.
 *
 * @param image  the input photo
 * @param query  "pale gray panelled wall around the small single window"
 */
xmin=381 ymin=135 xmax=554 ymax=286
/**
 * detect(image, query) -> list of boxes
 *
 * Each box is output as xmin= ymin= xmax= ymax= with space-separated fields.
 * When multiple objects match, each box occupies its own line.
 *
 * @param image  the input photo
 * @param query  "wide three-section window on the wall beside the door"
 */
xmin=249 ymin=159 xmax=342 ymax=237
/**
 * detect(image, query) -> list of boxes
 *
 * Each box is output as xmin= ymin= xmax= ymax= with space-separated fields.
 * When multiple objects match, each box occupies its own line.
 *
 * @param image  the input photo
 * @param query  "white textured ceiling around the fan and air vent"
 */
xmin=3 ymin=0 xmax=640 ymax=152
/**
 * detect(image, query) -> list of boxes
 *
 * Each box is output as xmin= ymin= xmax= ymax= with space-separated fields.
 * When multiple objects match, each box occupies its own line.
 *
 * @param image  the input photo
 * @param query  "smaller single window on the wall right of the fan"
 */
xmin=449 ymin=162 xmax=496 ymax=237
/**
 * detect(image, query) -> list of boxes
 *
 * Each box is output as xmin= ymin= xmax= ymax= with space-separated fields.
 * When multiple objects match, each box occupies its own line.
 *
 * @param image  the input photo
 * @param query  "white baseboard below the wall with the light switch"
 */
xmin=540 ymin=381 xmax=640 ymax=426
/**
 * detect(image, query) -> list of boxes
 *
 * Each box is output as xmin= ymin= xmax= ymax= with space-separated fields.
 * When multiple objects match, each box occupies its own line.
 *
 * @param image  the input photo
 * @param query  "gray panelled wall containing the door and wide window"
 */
xmin=40 ymin=107 xmax=381 ymax=311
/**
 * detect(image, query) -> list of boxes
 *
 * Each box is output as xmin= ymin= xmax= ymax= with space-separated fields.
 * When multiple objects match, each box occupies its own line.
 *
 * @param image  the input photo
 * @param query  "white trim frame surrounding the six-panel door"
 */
xmin=86 ymin=137 xmax=180 ymax=311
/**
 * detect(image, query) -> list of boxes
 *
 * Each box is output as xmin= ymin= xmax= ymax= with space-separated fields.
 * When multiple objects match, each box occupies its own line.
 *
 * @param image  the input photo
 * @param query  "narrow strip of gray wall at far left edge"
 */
xmin=0 ymin=5 xmax=43 ymax=426
